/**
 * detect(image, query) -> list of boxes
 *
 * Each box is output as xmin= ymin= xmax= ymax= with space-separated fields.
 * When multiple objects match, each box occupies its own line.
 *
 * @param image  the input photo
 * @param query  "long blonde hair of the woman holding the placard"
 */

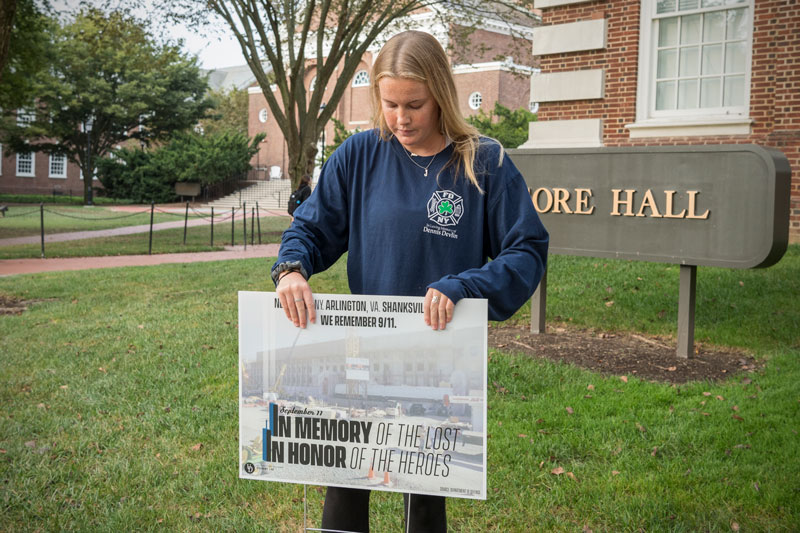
xmin=370 ymin=31 xmax=503 ymax=192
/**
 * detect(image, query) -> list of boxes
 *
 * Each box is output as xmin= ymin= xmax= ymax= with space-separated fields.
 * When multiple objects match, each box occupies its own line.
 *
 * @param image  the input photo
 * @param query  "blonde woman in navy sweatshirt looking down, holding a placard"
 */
xmin=272 ymin=31 xmax=548 ymax=532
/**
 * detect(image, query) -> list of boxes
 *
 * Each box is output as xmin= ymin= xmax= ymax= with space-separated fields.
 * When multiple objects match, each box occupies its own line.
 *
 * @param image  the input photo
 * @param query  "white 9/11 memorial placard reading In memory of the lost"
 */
xmin=239 ymin=292 xmax=487 ymax=499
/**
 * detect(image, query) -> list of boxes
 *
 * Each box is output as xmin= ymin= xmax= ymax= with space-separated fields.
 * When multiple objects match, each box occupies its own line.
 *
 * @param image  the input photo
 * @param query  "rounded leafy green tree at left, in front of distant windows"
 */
xmin=0 ymin=9 xmax=209 ymax=204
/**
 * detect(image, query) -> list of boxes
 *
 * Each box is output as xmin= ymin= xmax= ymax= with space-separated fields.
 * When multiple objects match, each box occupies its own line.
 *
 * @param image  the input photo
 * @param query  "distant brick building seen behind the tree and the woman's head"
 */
xmin=248 ymin=16 xmax=536 ymax=179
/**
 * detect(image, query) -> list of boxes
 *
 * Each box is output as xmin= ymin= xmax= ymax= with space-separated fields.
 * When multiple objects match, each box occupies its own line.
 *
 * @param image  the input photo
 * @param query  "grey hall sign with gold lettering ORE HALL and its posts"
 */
xmin=509 ymin=145 xmax=791 ymax=357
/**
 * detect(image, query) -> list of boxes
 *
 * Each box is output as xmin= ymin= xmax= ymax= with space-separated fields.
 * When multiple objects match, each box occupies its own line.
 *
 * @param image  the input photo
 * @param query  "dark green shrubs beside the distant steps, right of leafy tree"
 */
xmin=98 ymin=131 xmax=264 ymax=203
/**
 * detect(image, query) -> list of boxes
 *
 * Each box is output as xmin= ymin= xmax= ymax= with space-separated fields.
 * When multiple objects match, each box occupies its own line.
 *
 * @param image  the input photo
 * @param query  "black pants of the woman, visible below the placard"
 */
xmin=322 ymin=487 xmax=447 ymax=533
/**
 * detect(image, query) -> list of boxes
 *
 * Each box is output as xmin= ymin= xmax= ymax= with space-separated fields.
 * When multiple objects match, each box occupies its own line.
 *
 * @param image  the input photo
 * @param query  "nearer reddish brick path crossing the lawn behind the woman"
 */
xmin=0 ymin=243 xmax=280 ymax=277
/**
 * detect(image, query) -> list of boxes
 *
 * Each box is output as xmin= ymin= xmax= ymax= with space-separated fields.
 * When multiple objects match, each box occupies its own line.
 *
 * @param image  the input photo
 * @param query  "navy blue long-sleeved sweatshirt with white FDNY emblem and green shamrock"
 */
xmin=276 ymin=130 xmax=548 ymax=320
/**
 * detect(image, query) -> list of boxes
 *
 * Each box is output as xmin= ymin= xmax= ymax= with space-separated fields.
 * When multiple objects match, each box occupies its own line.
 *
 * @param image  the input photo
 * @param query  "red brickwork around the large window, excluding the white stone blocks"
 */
xmin=534 ymin=0 xmax=800 ymax=242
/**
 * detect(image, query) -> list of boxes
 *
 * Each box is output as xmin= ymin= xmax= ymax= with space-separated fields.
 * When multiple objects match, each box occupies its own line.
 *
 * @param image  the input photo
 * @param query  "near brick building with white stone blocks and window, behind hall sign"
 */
xmin=525 ymin=0 xmax=800 ymax=242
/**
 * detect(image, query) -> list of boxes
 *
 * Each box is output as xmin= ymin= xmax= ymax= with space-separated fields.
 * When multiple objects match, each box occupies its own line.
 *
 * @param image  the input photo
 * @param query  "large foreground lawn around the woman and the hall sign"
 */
xmin=0 ymin=246 xmax=800 ymax=532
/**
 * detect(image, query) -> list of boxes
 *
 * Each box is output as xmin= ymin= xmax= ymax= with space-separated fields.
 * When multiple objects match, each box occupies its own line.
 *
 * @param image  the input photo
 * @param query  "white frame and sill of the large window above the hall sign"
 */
xmin=626 ymin=0 xmax=755 ymax=138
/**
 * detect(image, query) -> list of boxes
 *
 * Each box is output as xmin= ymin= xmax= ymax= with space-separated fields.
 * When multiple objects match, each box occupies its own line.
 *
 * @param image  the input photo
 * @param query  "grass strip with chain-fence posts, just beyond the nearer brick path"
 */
xmin=0 ymin=214 xmax=289 ymax=259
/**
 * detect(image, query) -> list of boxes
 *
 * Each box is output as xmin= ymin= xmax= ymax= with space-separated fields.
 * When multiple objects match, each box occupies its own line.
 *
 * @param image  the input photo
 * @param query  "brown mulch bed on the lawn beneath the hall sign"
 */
xmin=489 ymin=320 xmax=761 ymax=383
